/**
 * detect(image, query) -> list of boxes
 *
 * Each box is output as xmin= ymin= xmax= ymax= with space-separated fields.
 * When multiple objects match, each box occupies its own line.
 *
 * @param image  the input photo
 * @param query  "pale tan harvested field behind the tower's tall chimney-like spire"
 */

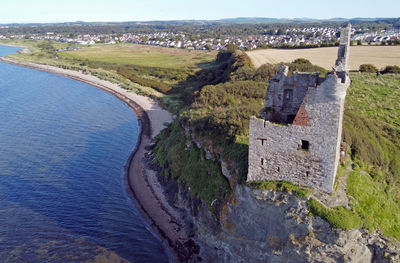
xmin=247 ymin=46 xmax=400 ymax=70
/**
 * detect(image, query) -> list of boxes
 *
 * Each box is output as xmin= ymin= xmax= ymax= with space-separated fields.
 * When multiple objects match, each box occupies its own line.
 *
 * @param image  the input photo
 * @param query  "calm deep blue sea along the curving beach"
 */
xmin=0 ymin=46 xmax=168 ymax=263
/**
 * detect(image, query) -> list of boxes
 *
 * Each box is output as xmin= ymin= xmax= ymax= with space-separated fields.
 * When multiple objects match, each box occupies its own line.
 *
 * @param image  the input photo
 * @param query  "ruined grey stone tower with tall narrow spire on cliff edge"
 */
xmin=247 ymin=25 xmax=351 ymax=193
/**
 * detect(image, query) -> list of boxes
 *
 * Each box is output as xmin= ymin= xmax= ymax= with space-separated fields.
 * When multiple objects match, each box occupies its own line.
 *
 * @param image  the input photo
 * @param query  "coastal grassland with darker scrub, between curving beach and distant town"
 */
xmin=0 ymin=40 xmax=217 ymax=99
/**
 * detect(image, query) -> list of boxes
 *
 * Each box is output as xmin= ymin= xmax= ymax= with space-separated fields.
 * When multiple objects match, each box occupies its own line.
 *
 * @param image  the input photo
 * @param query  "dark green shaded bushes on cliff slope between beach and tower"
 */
xmin=154 ymin=119 xmax=232 ymax=212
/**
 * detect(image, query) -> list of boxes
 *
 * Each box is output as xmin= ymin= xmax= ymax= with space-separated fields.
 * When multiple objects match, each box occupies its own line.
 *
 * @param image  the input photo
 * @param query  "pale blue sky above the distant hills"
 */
xmin=0 ymin=0 xmax=400 ymax=23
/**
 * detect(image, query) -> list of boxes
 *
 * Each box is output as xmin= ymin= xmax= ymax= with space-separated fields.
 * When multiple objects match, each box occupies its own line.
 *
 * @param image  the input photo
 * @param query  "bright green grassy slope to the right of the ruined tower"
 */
xmin=309 ymin=73 xmax=400 ymax=240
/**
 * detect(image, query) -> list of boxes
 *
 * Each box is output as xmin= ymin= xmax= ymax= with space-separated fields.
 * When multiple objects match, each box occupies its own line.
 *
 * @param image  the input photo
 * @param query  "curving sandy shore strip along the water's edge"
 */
xmin=0 ymin=57 xmax=198 ymax=261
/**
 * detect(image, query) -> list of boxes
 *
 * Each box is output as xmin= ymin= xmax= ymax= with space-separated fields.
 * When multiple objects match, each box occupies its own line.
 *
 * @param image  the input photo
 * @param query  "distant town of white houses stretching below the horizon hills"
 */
xmin=0 ymin=26 xmax=400 ymax=51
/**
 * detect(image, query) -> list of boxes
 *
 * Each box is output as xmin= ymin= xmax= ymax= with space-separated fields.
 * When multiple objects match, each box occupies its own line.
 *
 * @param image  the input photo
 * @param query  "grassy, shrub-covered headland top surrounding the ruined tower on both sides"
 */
xmin=156 ymin=53 xmax=400 ymax=239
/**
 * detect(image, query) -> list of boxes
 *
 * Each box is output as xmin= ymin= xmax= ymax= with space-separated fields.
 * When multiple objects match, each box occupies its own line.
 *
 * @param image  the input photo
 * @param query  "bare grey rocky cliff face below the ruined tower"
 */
xmin=167 ymin=180 xmax=400 ymax=262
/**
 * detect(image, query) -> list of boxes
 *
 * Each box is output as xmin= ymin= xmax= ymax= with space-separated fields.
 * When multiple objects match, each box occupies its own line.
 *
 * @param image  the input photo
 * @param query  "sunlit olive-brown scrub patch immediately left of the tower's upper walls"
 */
xmin=182 ymin=81 xmax=266 ymax=143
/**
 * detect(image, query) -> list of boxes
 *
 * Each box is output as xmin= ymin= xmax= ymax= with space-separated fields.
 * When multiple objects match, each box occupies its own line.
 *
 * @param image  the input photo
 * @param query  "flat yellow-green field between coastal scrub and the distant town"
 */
xmin=61 ymin=44 xmax=216 ymax=69
